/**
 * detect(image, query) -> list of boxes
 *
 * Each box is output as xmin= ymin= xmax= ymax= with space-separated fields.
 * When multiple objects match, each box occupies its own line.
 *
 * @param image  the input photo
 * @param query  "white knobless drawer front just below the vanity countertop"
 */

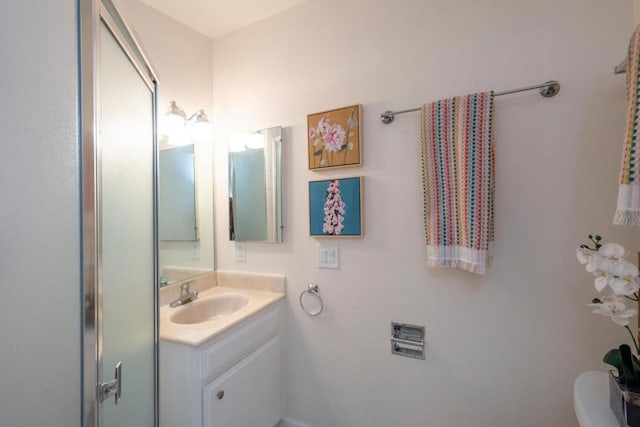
xmin=200 ymin=304 xmax=280 ymax=380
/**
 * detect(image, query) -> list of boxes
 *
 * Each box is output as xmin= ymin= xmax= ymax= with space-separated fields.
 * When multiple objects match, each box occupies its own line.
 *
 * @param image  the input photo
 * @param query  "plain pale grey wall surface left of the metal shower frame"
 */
xmin=0 ymin=0 xmax=81 ymax=427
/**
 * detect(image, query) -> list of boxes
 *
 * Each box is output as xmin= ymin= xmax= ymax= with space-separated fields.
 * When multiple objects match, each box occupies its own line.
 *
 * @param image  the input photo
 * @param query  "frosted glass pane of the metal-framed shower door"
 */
xmin=97 ymin=22 xmax=156 ymax=427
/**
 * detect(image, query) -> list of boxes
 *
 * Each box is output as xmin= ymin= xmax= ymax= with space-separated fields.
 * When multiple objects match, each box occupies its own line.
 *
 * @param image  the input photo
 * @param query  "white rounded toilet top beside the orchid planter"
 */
xmin=573 ymin=371 xmax=619 ymax=427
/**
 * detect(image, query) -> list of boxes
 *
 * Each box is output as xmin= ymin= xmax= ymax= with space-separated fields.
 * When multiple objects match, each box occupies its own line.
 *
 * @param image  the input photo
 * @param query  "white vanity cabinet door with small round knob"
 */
xmin=202 ymin=336 xmax=282 ymax=427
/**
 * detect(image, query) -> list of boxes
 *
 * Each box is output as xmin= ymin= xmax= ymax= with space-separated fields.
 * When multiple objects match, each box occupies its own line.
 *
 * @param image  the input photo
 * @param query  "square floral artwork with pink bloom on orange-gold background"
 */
xmin=307 ymin=105 xmax=362 ymax=170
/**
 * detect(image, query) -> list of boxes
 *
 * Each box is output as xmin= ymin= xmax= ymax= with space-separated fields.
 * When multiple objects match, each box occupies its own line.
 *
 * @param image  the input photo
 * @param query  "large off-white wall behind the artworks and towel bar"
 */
xmin=213 ymin=0 xmax=640 ymax=427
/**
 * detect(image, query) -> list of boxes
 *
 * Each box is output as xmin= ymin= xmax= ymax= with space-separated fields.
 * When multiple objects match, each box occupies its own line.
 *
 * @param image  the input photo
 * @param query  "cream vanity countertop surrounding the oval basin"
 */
xmin=160 ymin=286 xmax=284 ymax=346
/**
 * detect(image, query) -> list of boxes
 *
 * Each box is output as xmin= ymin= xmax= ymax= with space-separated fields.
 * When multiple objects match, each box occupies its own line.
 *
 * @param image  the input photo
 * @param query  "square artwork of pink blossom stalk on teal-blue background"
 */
xmin=309 ymin=177 xmax=364 ymax=237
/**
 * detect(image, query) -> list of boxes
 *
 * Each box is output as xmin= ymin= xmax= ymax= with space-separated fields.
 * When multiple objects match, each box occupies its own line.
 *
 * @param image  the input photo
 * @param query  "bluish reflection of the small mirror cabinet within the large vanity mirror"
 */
xmin=158 ymin=144 xmax=198 ymax=241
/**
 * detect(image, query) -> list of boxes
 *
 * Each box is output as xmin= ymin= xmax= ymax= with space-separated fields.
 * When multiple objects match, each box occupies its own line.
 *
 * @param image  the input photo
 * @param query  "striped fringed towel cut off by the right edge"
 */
xmin=613 ymin=25 xmax=640 ymax=225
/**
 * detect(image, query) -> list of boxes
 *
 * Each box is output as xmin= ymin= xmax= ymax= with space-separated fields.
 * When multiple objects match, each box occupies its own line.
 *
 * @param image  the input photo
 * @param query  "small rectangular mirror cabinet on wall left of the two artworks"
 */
xmin=229 ymin=126 xmax=284 ymax=242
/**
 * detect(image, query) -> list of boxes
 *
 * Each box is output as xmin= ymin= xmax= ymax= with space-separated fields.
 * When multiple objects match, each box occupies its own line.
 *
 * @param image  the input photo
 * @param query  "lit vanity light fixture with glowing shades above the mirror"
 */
xmin=160 ymin=101 xmax=213 ymax=145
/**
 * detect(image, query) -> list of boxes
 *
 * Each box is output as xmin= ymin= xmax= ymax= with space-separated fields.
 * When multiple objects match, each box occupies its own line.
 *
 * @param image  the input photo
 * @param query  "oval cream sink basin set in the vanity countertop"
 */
xmin=170 ymin=293 xmax=249 ymax=325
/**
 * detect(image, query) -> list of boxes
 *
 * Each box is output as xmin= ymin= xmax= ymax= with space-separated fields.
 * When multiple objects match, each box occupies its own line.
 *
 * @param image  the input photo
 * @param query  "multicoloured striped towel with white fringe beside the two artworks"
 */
xmin=421 ymin=92 xmax=495 ymax=274
